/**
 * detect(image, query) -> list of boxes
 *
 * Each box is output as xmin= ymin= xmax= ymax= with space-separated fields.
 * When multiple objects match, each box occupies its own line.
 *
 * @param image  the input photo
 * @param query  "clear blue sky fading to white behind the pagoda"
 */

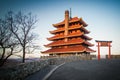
xmin=0 ymin=0 xmax=120 ymax=55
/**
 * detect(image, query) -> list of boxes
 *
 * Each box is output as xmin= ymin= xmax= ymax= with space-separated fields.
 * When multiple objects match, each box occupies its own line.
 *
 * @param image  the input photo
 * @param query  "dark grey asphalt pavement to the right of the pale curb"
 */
xmin=47 ymin=60 xmax=120 ymax=80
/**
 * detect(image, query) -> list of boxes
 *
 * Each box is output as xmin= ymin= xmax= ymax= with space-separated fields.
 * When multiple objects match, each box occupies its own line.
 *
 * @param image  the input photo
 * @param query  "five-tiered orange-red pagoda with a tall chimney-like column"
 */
xmin=42 ymin=10 xmax=95 ymax=56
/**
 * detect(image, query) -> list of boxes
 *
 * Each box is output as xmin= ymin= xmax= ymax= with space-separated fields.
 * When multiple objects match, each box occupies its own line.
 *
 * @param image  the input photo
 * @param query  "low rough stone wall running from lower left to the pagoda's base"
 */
xmin=0 ymin=55 xmax=91 ymax=80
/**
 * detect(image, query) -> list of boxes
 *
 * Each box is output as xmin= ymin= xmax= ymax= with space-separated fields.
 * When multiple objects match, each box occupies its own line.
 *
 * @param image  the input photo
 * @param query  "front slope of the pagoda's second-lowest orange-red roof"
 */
xmin=45 ymin=38 xmax=85 ymax=47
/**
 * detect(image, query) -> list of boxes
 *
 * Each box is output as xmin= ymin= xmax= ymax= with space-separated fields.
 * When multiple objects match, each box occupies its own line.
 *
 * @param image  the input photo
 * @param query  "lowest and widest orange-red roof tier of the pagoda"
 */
xmin=42 ymin=45 xmax=95 ymax=54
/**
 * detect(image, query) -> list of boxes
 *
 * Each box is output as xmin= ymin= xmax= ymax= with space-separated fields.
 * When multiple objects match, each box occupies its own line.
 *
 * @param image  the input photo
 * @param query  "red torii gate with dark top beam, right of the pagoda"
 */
xmin=95 ymin=40 xmax=112 ymax=60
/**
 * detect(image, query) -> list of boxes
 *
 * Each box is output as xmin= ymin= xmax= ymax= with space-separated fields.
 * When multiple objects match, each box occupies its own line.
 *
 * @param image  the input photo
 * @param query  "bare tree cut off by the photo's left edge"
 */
xmin=0 ymin=19 xmax=17 ymax=66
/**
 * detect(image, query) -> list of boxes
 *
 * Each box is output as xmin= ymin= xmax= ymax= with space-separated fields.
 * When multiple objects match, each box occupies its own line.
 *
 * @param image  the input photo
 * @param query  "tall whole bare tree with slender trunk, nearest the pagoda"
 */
xmin=8 ymin=12 xmax=37 ymax=62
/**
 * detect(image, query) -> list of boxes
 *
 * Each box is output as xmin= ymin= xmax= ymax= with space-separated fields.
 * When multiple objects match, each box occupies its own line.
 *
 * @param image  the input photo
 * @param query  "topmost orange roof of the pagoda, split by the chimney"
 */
xmin=53 ymin=17 xmax=87 ymax=27
